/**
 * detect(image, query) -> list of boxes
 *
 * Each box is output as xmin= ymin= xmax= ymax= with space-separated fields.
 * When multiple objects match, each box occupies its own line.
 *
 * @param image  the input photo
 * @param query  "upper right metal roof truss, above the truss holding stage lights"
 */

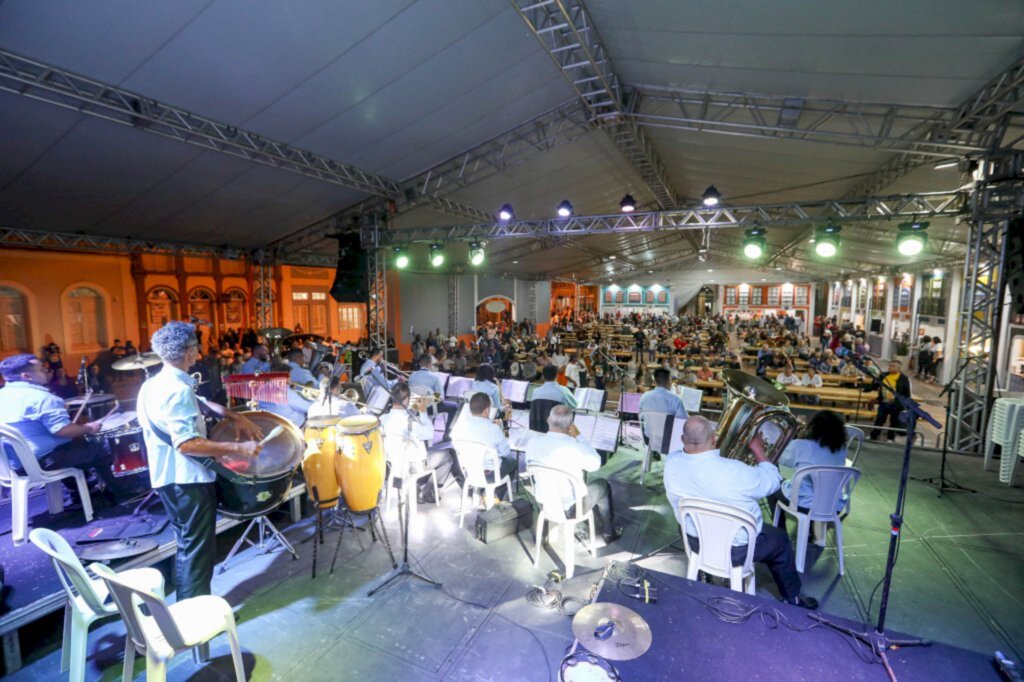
xmin=627 ymin=86 xmax=991 ymax=157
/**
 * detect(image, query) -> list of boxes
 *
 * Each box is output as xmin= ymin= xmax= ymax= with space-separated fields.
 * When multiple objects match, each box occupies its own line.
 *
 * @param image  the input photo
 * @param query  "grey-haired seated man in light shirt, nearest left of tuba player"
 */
xmin=526 ymin=403 xmax=623 ymax=544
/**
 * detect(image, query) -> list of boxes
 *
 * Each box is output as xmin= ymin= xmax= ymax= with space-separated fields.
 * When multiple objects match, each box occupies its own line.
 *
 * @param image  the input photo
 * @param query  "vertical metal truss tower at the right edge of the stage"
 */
xmin=946 ymin=155 xmax=1024 ymax=452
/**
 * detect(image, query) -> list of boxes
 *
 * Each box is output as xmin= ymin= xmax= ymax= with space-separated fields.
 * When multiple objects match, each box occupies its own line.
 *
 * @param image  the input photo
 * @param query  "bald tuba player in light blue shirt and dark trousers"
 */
xmin=659 ymin=417 xmax=818 ymax=608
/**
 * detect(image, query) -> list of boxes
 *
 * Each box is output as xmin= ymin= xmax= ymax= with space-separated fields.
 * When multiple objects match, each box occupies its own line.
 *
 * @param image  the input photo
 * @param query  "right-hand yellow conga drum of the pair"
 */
xmin=334 ymin=415 xmax=385 ymax=512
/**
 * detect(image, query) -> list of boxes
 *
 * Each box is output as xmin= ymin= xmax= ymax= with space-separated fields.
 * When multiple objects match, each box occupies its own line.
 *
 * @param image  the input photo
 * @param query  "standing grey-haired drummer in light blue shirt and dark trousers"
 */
xmin=136 ymin=322 xmax=262 ymax=601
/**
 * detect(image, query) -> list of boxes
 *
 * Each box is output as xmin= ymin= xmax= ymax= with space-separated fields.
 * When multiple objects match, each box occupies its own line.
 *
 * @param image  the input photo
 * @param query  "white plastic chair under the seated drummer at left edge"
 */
xmin=0 ymin=424 xmax=92 ymax=546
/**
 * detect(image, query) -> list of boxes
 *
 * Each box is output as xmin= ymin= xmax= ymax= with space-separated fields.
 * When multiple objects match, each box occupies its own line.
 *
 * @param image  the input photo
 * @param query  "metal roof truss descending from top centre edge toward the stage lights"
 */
xmin=512 ymin=0 xmax=678 ymax=209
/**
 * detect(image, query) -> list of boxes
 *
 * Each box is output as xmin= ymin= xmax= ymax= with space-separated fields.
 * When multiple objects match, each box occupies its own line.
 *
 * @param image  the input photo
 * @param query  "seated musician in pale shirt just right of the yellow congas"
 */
xmin=380 ymin=381 xmax=464 ymax=504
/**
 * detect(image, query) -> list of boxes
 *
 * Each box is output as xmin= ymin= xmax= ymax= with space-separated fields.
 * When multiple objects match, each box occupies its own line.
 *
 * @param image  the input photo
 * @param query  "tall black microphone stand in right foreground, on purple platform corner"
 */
xmin=809 ymin=353 xmax=942 ymax=680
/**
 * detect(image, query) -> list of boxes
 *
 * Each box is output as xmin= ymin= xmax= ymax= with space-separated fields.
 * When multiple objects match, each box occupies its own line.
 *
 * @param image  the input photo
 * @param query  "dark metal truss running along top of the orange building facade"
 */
xmin=0 ymin=227 xmax=338 ymax=267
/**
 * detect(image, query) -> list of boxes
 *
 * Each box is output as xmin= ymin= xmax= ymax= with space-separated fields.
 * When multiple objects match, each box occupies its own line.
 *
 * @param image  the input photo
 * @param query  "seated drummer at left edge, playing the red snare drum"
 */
xmin=0 ymin=353 xmax=114 ymax=504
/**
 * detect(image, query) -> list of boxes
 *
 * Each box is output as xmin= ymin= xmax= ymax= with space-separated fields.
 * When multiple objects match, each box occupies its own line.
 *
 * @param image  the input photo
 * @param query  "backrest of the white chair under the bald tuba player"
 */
xmin=679 ymin=498 xmax=757 ymax=573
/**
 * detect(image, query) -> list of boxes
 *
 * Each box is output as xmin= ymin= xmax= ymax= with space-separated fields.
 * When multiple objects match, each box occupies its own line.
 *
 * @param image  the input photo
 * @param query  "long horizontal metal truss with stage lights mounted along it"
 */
xmin=362 ymin=191 xmax=965 ymax=246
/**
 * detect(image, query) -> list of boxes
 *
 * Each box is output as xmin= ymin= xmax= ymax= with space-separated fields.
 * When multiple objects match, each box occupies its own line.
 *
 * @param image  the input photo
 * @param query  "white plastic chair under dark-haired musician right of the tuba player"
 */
xmin=772 ymin=465 xmax=860 ymax=576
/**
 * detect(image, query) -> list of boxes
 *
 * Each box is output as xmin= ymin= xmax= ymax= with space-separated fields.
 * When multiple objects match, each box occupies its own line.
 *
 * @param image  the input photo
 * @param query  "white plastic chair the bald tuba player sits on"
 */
xmin=679 ymin=498 xmax=758 ymax=594
